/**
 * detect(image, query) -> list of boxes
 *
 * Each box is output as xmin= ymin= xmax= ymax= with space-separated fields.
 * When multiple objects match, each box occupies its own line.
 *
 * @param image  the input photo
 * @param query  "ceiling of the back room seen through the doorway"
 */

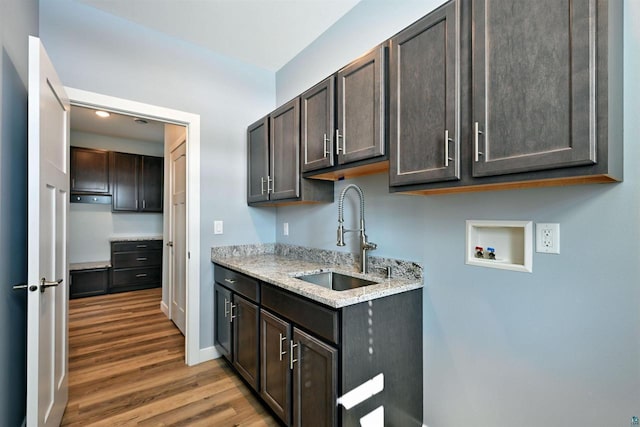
xmin=71 ymin=105 xmax=164 ymax=144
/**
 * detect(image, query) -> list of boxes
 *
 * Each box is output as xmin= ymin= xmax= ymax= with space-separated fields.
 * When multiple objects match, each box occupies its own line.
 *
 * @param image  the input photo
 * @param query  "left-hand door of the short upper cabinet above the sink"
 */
xmin=300 ymin=76 xmax=335 ymax=172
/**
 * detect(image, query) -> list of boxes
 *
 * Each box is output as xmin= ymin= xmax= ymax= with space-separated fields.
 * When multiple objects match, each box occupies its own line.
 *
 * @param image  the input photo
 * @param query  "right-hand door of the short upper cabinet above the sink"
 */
xmin=336 ymin=46 xmax=385 ymax=164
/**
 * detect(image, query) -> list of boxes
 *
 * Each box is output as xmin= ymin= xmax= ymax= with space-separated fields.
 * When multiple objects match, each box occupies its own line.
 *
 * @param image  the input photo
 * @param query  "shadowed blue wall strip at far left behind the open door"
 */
xmin=0 ymin=0 xmax=38 ymax=427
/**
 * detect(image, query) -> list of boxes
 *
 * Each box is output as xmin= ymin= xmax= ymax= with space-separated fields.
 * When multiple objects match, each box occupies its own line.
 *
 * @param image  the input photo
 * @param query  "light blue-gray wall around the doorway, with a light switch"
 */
xmin=40 ymin=0 xmax=275 ymax=348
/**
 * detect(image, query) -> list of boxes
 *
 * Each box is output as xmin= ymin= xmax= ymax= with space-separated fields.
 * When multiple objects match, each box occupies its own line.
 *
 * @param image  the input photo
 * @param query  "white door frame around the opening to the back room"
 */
xmin=65 ymin=87 xmax=200 ymax=366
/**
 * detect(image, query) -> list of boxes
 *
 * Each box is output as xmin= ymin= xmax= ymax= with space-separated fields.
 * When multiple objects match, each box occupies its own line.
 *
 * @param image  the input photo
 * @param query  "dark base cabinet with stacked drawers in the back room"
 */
xmin=109 ymin=240 xmax=162 ymax=293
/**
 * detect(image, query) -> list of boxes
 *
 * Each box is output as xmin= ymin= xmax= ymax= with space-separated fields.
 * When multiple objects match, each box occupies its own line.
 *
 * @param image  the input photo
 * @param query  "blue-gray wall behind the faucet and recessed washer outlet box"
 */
xmin=276 ymin=0 xmax=640 ymax=427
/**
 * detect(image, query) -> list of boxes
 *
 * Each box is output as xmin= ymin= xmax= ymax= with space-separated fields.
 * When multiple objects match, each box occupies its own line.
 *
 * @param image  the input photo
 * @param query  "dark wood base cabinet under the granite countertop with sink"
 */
xmin=214 ymin=265 xmax=422 ymax=427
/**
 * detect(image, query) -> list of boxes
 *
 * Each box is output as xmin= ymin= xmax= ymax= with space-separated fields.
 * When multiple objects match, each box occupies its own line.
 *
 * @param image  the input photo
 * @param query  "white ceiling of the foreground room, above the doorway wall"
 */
xmin=77 ymin=0 xmax=360 ymax=71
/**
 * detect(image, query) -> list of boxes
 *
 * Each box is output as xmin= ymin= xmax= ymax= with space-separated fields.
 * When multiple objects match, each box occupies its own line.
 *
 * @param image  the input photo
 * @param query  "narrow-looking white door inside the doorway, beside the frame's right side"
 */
xmin=169 ymin=142 xmax=187 ymax=335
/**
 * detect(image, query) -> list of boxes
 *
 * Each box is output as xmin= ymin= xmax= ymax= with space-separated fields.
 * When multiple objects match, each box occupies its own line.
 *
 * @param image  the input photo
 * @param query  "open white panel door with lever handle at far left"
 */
xmin=27 ymin=37 xmax=69 ymax=427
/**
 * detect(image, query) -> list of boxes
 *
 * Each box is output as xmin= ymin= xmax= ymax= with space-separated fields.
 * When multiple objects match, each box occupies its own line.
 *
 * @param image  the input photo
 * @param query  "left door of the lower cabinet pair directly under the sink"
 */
xmin=260 ymin=310 xmax=291 ymax=425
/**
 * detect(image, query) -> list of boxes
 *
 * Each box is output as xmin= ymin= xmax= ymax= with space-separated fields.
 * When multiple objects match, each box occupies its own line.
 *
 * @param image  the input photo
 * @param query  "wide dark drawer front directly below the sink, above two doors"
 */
xmin=262 ymin=285 xmax=339 ymax=344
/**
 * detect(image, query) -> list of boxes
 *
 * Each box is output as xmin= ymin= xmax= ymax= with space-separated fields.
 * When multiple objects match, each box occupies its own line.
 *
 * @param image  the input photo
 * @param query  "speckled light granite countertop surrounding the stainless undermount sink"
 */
xmin=211 ymin=254 xmax=423 ymax=308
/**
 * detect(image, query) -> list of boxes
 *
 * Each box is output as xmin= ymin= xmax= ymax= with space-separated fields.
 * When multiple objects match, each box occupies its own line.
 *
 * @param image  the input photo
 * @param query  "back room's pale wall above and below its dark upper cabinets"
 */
xmin=67 ymin=131 xmax=164 ymax=263
